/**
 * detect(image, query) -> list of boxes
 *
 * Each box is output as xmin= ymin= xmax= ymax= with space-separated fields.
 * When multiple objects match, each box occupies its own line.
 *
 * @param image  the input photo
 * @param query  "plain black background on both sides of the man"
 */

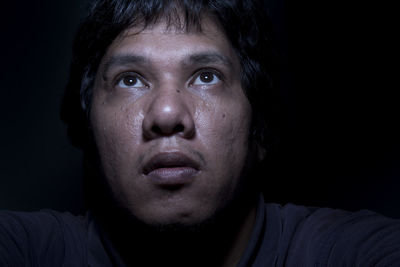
xmin=0 ymin=0 xmax=400 ymax=218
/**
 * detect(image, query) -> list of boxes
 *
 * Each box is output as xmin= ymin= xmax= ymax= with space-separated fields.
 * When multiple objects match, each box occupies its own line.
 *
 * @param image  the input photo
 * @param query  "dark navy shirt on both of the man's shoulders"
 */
xmin=0 ymin=201 xmax=400 ymax=267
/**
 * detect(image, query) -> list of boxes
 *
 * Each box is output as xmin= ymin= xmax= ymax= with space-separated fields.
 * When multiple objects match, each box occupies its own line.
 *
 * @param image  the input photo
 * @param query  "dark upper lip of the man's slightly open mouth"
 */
xmin=143 ymin=152 xmax=199 ymax=175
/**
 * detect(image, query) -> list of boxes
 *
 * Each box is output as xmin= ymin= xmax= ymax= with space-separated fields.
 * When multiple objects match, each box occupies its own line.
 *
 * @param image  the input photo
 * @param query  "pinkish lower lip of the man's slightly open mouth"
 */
xmin=147 ymin=167 xmax=198 ymax=186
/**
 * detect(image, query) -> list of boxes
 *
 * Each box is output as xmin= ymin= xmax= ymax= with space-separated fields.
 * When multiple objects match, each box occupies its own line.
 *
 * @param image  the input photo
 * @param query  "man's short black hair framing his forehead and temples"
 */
xmin=61 ymin=0 xmax=277 ymax=154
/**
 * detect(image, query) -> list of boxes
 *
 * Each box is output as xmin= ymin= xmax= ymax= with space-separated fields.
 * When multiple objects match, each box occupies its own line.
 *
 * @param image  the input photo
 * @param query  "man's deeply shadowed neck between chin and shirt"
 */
xmin=97 ymin=194 xmax=257 ymax=267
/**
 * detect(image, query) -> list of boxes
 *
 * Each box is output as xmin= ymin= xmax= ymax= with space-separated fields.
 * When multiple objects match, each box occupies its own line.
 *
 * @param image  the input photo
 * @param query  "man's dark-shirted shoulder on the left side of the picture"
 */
xmin=0 ymin=210 xmax=87 ymax=266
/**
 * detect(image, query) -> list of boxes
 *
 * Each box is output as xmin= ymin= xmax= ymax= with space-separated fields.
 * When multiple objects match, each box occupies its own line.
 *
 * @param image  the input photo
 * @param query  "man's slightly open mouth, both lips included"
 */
xmin=143 ymin=152 xmax=200 ymax=186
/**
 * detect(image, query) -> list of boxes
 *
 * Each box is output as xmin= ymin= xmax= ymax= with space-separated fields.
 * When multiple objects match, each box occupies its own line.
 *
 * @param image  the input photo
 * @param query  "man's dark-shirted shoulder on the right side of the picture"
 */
xmin=265 ymin=204 xmax=400 ymax=266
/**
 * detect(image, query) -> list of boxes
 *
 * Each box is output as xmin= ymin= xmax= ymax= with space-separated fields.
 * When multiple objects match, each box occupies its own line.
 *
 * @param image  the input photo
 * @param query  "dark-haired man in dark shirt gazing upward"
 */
xmin=0 ymin=0 xmax=400 ymax=266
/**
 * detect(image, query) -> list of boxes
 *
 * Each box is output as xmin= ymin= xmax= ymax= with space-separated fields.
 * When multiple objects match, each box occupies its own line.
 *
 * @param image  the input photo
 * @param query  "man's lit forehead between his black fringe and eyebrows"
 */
xmin=103 ymin=17 xmax=239 ymax=69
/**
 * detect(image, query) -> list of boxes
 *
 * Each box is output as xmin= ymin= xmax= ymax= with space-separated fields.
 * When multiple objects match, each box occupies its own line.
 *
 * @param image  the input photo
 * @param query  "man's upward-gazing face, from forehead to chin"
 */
xmin=90 ymin=19 xmax=251 ymax=225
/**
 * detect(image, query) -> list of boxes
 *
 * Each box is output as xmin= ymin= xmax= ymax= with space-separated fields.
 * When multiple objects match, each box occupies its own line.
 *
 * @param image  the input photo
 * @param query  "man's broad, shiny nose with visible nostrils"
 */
xmin=143 ymin=88 xmax=195 ymax=140
